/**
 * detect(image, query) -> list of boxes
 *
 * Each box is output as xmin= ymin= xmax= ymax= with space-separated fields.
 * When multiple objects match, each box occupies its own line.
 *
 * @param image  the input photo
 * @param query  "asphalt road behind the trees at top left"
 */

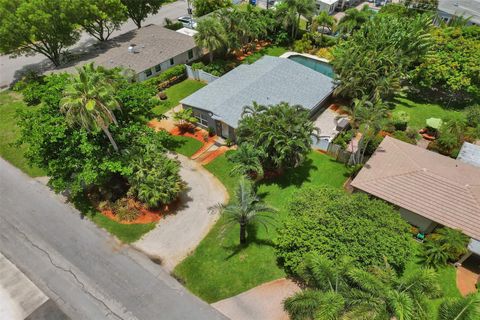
xmin=0 ymin=0 xmax=191 ymax=89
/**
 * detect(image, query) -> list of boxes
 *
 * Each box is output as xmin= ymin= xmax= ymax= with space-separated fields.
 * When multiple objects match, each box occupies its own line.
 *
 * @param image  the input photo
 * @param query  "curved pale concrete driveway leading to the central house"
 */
xmin=134 ymin=155 xmax=228 ymax=271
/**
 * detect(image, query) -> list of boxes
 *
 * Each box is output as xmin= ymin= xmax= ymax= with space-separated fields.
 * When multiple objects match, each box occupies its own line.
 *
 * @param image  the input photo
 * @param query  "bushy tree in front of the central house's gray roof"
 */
xmin=237 ymin=102 xmax=318 ymax=170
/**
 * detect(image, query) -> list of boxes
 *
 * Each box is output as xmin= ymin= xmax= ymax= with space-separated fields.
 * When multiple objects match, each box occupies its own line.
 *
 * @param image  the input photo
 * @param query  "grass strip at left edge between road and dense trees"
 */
xmin=0 ymin=91 xmax=45 ymax=177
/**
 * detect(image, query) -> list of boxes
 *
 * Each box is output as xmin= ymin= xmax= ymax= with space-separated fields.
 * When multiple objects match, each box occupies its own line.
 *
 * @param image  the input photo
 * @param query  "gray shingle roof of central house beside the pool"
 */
xmin=180 ymin=56 xmax=334 ymax=128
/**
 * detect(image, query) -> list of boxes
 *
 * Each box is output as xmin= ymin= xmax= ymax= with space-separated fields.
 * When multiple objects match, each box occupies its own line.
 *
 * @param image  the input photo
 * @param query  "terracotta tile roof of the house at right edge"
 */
xmin=352 ymin=137 xmax=480 ymax=239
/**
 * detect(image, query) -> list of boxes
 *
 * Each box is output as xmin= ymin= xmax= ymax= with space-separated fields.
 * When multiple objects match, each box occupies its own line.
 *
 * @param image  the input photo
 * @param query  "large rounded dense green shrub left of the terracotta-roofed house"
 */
xmin=275 ymin=186 xmax=412 ymax=271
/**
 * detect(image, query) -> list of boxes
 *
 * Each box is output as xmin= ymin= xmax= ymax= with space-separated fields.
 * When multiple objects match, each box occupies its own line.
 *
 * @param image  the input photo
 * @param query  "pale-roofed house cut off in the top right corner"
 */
xmin=438 ymin=0 xmax=480 ymax=25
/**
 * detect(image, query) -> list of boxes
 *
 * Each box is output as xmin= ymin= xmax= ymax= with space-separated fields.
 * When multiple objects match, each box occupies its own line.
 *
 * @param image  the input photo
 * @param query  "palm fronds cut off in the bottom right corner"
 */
xmin=438 ymin=293 xmax=480 ymax=320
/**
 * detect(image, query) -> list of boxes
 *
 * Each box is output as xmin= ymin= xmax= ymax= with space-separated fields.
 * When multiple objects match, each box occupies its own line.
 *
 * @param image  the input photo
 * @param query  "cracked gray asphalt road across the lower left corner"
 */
xmin=0 ymin=158 xmax=226 ymax=320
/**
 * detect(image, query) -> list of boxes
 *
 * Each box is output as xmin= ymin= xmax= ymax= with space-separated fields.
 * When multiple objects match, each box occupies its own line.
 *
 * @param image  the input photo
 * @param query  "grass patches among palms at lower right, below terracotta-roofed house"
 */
xmin=405 ymin=242 xmax=461 ymax=320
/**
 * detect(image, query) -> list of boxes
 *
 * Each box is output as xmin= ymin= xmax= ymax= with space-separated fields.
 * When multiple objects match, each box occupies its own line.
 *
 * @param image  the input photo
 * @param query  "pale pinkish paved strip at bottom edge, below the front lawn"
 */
xmin=212 ymin=279 xmax=300 ymax=320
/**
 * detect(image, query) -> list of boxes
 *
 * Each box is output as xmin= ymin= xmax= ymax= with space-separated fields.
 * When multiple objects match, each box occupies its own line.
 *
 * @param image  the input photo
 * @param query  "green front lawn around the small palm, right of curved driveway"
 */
xmin=174 ymin=152 xmax=346 ymax=302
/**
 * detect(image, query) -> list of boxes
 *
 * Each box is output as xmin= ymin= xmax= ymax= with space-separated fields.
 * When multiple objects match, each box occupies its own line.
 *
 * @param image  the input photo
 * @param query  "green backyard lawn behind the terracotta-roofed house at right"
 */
xmin=393 ymin=98 xmax=461 ymax=130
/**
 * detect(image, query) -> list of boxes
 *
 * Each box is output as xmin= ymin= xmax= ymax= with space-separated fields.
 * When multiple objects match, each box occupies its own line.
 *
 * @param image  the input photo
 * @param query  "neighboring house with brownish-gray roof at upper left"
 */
xmin=54 ymin=24 xmax=201 ymax=81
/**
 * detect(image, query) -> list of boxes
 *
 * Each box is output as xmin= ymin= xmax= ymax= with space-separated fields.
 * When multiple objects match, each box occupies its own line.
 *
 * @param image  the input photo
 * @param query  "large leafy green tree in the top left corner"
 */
xmin=0 ymin=0 xmax=80 ymax=66
